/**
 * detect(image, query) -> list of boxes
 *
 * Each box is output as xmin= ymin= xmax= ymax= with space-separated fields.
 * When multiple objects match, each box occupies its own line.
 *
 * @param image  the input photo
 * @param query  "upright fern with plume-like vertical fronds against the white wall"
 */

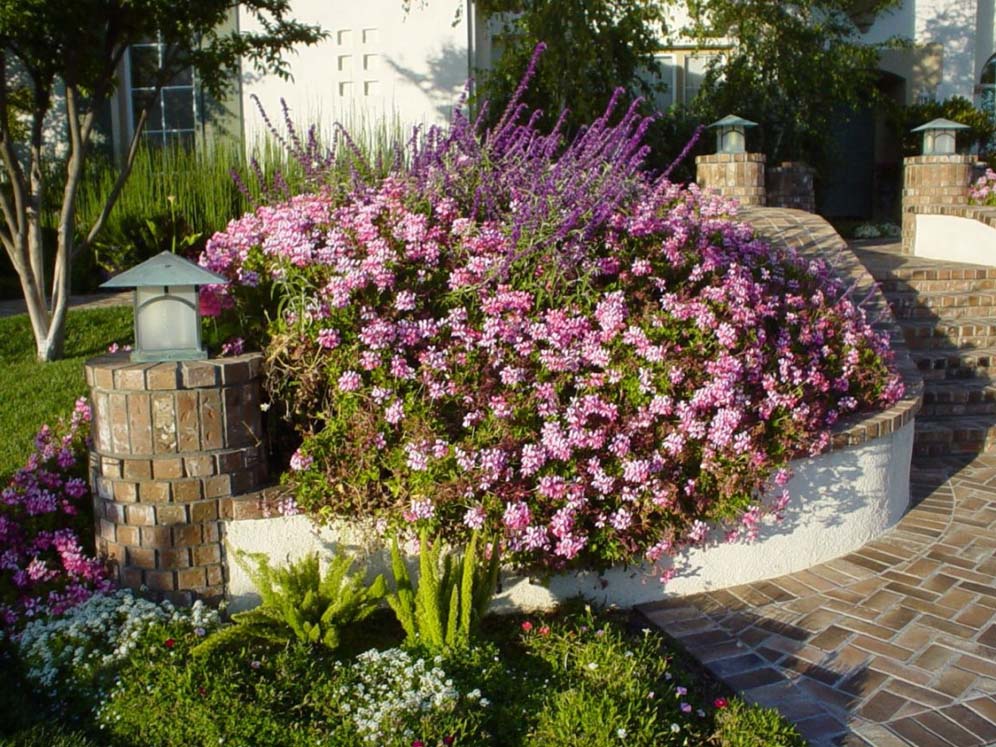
xmin=387 ymin=529 xmax=500 ymax=651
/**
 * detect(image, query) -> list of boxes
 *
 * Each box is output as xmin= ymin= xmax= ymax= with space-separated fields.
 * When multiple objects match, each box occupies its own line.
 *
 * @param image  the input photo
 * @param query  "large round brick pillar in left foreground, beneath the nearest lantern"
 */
xmin=86 ymin=353 xmax=266 ymax=604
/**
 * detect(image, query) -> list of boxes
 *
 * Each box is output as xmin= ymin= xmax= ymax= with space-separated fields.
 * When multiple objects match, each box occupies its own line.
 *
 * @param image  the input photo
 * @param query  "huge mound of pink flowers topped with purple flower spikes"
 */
xmin=201 ymin=45 xmax=903 ymax=579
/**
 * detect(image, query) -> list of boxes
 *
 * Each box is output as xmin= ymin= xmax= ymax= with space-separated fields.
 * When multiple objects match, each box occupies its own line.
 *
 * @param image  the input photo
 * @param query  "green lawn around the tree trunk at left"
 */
xmin=0 ymin=307 xmax=133 ymax=477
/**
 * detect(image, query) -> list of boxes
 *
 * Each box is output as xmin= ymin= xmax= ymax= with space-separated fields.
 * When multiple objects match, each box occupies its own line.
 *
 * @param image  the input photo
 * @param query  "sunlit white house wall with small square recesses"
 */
xmin=239 ymin=0 xmax=470 ymax=143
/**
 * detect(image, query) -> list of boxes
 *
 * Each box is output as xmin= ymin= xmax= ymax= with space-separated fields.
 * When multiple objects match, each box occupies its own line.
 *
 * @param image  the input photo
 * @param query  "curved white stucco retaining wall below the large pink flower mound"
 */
xmin=227 ymin=421 xmax=913 ymax=611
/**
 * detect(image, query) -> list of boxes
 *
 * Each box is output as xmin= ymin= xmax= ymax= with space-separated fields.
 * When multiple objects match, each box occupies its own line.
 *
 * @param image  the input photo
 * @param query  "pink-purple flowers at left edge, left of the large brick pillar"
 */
xmin=0 ymin=399 xmax=111 ymax=628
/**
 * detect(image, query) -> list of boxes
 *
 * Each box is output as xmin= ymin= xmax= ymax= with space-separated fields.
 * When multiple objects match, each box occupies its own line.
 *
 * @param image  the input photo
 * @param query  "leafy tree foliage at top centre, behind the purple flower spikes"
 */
xmin=477 ymin=0 xmax=668 ymax=133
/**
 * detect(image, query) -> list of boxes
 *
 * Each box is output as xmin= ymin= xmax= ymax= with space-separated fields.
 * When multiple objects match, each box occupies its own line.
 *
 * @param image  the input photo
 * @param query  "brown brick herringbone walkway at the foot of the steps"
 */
xmin=641 ymin=454 xmax=996 ymax=747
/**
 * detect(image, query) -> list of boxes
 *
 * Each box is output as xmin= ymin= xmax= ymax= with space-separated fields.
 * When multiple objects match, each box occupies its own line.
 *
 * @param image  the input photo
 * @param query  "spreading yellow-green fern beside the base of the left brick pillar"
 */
xmin=194 ymin=552 xmax=385 ymax=656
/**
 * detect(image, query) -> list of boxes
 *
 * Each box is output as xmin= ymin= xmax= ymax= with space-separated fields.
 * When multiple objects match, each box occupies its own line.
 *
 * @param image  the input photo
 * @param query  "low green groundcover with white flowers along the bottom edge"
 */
xmin=11 ymin=605 xmax=804 ymax=747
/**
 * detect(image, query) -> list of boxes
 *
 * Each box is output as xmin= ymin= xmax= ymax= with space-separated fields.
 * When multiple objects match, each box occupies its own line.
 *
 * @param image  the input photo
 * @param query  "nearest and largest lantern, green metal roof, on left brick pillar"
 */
xmin=100 ymin=252 xmax=228 ymax=362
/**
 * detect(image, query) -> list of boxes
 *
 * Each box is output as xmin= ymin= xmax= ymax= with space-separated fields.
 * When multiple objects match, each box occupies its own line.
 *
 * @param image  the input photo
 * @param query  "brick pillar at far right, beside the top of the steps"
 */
xmin=903 ymin=155 xmax=976 ymax=254
